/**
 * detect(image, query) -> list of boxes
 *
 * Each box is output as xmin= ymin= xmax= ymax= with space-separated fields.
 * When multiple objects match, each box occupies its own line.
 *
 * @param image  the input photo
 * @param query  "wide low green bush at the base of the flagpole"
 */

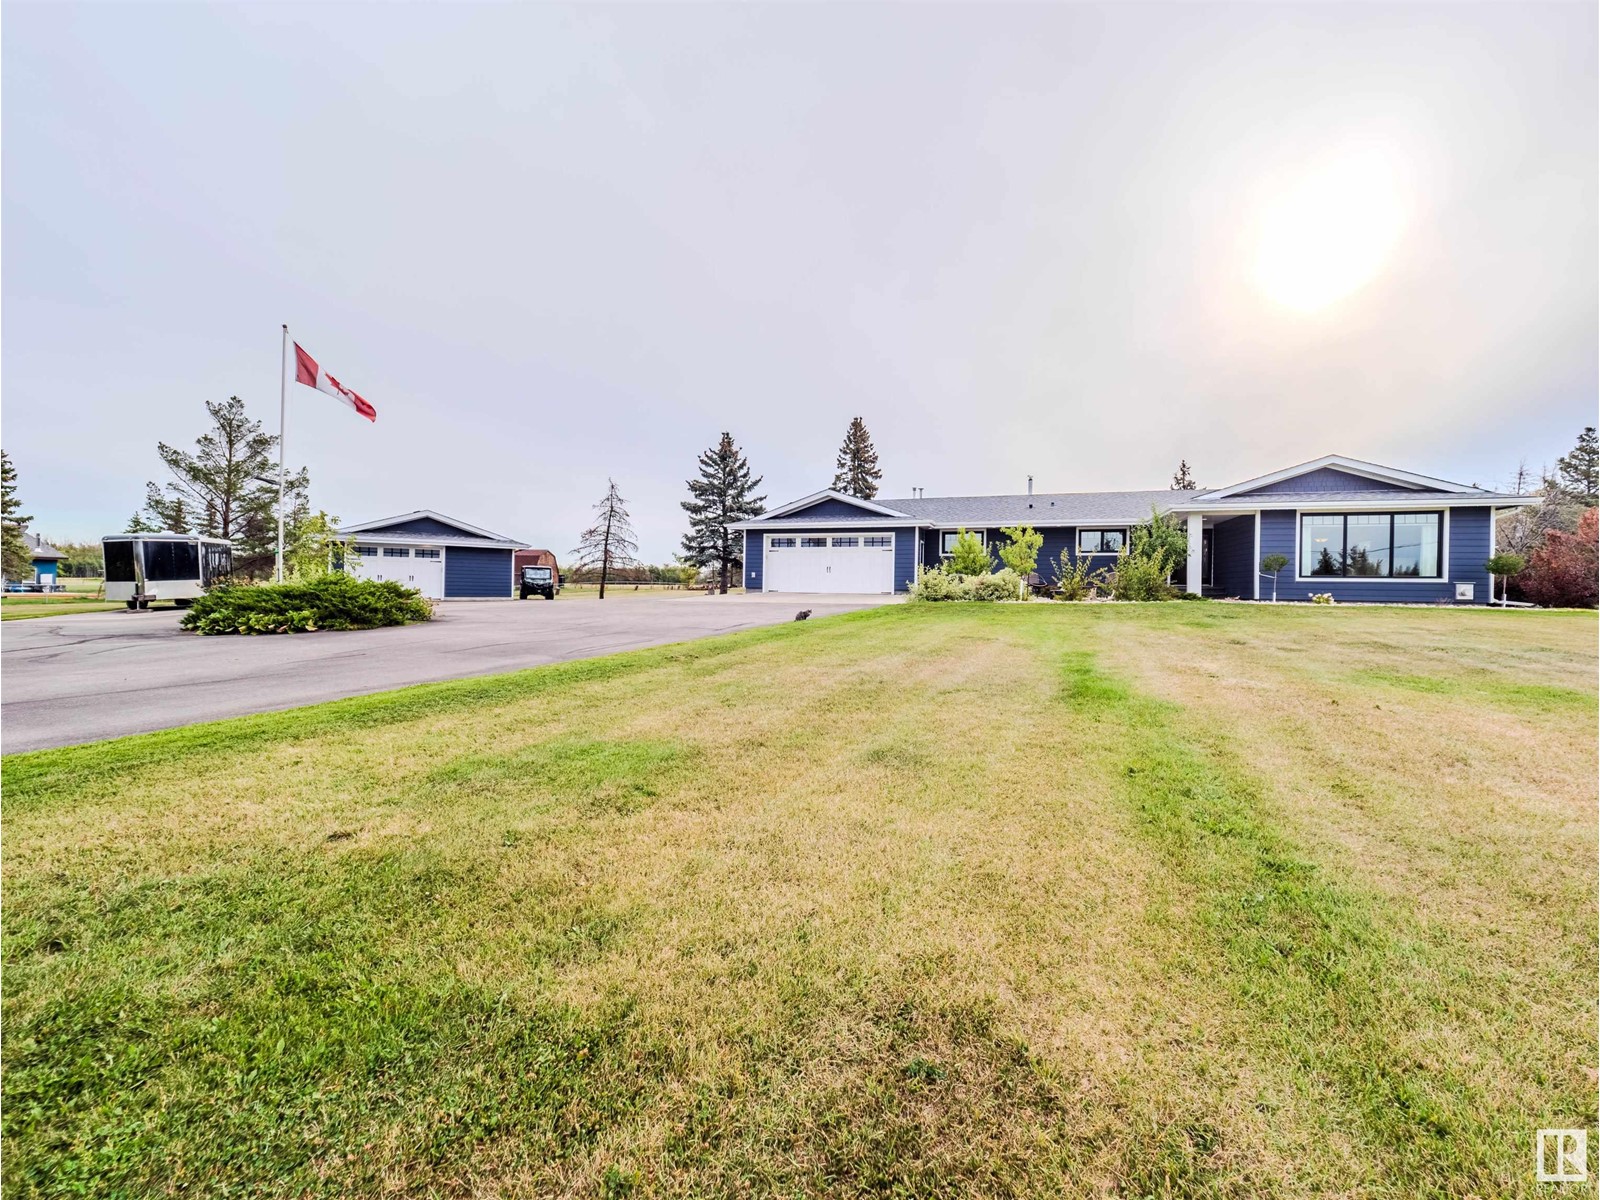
xmin=179 ymin=574 xmax=434 ymax=634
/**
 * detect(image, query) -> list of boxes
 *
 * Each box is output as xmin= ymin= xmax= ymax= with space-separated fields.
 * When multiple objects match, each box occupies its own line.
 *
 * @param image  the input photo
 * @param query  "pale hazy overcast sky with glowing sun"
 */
xmin=0 ymin=2 xmax=1600 ymax=562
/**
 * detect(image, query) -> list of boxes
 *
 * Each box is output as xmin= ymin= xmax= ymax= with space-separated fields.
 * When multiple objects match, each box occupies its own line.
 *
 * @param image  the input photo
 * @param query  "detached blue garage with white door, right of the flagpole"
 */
xmin=339 ymin=509 xmax=523 ymax=600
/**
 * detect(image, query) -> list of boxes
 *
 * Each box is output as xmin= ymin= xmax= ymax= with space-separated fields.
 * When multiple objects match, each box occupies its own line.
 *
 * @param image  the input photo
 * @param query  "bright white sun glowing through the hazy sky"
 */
xmin=1256 ymin=155 xmax=1405 ymax=312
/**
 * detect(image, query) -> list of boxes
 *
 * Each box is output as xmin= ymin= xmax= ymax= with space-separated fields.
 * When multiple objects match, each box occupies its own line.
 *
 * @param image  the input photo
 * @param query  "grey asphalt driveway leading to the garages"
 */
xmin=0 ymin=592 xmax=896 ymax=754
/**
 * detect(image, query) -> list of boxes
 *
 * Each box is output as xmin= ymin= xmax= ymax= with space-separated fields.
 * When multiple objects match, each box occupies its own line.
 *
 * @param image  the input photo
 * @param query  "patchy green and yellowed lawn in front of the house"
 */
xmin=0 ymin=603 xmax=1597 ymax=1198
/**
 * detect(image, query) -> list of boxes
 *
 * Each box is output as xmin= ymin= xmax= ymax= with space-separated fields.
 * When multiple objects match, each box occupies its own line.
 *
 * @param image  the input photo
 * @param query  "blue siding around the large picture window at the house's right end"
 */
xmin=1261 ymin=507 xmax=1493 ymax=605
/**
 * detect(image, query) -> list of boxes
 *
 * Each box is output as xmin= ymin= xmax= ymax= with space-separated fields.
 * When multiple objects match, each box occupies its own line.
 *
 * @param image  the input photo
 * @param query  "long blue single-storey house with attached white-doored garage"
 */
xmin=731 ymin=454 xmax=1538 ymax=605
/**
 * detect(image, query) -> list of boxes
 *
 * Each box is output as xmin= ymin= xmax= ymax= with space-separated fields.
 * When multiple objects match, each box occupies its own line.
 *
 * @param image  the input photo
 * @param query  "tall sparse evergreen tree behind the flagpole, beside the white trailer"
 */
xmin=142 ymin=395 xmax=310 ymax=574
